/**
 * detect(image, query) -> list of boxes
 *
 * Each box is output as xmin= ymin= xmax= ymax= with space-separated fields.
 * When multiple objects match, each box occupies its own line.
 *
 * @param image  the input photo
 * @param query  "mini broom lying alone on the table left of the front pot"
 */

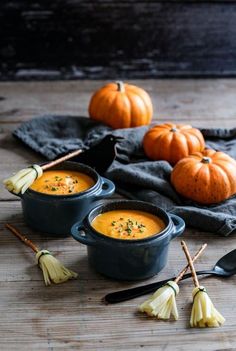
xmin=5 ymin=223 xmax=78 ymax=285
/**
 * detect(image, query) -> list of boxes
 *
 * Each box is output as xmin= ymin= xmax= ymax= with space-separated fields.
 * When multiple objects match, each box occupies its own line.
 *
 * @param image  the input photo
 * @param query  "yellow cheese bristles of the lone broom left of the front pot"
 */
xmin=36 ymin=250 xmax=78 ymax=285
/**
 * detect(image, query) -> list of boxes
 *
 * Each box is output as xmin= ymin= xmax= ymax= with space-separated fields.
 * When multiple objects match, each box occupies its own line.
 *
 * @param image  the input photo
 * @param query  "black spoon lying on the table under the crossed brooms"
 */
xmin=104 ymin=249 xmax=236 ymax=303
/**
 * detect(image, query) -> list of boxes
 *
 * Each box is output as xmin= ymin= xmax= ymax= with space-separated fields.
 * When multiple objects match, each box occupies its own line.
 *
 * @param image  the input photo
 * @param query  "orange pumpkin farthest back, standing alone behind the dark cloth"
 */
xmin=89 ymin=82 xmax=153 ymax=129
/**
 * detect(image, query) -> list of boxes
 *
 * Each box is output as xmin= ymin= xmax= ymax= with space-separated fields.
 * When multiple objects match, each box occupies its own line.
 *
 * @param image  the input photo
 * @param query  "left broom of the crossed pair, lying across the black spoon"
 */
xmin=139 ymin=244 xmax=207 ymax=320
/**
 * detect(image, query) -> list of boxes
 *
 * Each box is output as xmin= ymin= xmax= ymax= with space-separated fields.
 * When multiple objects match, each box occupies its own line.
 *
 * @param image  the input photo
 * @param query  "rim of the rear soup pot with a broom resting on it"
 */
xmin=25 ymin=161 xmax=101 ymax=200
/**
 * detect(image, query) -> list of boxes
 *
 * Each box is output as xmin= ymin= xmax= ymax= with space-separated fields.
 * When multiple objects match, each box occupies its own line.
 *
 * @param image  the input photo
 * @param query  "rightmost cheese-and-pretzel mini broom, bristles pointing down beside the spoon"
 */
xmin=181 ymin=241 xmax=225 ymax=328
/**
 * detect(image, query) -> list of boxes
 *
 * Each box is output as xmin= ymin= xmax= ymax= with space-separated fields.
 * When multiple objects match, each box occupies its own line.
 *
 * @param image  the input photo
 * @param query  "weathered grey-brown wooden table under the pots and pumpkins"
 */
xmin=0 ymin=80 xmax=236 ymax=351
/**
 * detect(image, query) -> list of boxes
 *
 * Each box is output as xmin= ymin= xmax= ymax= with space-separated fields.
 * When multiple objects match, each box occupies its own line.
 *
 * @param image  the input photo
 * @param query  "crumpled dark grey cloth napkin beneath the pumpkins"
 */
xmin=13 ymin=116 xmax=236 ymax=236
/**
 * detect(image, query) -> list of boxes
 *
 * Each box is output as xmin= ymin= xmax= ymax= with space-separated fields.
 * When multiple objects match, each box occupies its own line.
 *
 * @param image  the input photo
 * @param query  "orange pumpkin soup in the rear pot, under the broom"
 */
xmin=30 ymin=170 xmax=95 ymax=195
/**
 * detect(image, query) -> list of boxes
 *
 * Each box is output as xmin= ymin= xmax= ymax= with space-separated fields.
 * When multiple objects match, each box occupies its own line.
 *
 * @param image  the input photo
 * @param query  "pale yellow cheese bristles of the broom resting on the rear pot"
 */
xmin=3 ymin=165 xmax=43 ymax=194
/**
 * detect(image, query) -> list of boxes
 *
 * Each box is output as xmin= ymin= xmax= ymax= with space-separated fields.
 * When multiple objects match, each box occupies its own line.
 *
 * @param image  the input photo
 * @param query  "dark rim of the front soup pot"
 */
xmin=84 ymin=200 xmax=173 ymax=245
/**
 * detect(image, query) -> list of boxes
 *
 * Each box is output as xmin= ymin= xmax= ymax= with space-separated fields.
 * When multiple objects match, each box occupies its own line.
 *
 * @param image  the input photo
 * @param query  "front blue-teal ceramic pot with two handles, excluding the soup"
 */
xmin=71 ymin=200 xmax=185 ymax=280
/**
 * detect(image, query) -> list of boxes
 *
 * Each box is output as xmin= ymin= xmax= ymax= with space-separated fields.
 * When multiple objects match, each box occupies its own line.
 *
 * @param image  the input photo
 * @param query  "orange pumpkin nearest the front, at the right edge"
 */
xmin=171 ymin=149 xmax=236 ymax=205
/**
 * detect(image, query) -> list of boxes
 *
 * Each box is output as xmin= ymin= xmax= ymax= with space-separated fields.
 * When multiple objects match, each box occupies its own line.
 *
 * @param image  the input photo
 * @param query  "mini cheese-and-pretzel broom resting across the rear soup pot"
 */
xmin=3 ymin=150 xmax=82 ymax=194
